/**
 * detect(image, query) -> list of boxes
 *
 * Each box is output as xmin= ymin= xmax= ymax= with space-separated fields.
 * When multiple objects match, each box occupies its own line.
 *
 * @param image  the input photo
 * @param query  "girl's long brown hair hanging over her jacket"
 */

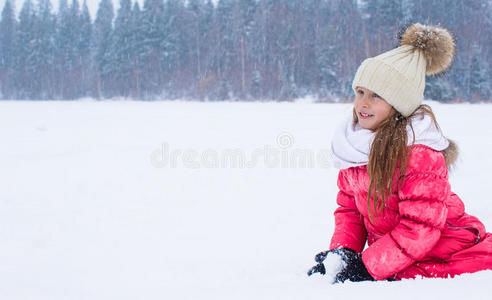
xmin=353 ymin=104 xmax=441 ymax=220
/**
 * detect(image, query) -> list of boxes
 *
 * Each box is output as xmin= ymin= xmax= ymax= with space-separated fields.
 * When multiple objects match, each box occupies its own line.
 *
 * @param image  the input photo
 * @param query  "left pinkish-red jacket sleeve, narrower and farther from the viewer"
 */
xmin=330 ymin=169 xmax=367 ymax=253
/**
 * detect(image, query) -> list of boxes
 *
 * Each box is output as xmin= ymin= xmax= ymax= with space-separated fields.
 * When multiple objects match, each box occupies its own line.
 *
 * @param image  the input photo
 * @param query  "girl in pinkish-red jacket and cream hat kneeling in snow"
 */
xmin=308 ymin=23 xmax=492 ymax=282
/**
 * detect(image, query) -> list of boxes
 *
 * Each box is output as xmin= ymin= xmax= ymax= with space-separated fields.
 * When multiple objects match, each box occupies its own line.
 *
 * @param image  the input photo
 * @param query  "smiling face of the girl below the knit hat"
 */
xmin=354 ymin=87 xmax=392 ymax=131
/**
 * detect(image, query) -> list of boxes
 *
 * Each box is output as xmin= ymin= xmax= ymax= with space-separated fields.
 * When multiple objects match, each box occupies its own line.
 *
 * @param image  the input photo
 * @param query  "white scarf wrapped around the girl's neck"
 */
xmin=331 ymin=111 xmax=449 ymax=169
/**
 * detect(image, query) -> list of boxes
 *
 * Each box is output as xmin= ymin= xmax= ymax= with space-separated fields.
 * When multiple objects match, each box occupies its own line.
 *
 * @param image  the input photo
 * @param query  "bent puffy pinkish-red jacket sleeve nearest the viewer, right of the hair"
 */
xmin=362 ymin=147 xmax=450 ymax=280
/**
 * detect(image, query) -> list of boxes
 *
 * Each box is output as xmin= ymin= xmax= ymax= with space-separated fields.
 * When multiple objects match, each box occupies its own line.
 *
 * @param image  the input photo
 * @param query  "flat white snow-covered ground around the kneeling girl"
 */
xmin=0 ymin=101 xmax=492 ymax=300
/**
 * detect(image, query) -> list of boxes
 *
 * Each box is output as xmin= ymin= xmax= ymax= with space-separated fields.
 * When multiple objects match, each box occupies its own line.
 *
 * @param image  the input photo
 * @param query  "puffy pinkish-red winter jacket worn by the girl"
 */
xmin=330 ymin=145 xmax=492 ymax=280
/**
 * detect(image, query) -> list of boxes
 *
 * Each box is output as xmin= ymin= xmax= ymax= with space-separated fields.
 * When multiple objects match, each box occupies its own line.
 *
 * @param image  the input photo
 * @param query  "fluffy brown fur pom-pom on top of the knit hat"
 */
xmin=401 ymin=23 xmax=455 ymax=75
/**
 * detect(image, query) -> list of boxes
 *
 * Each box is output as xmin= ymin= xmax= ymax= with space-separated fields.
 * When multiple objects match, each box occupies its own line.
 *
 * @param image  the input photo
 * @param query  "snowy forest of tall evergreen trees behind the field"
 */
xmin=0 ymin=0 xmax=492 ymax=102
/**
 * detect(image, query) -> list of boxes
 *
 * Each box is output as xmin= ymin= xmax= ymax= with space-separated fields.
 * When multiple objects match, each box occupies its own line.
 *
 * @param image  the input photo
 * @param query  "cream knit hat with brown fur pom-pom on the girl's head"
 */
xmin=352 ymin=23 xmax=455 ymax=117
